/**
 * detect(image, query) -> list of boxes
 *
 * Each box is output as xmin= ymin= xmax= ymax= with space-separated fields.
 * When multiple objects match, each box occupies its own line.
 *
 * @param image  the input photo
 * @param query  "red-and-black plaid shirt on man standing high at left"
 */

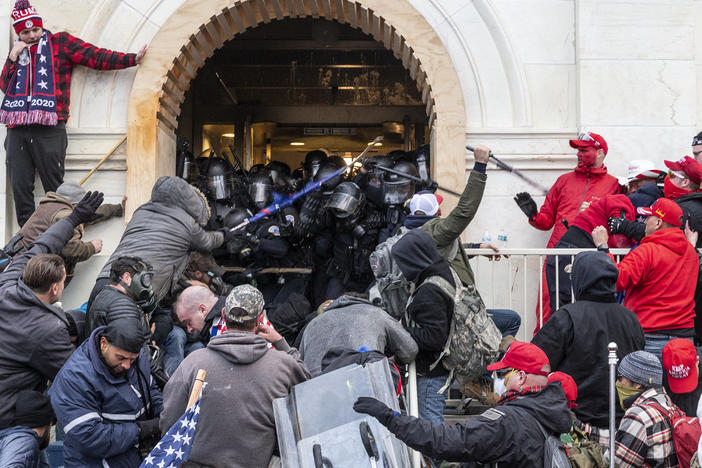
xmin=0 ymin=32 xmax=136 ymax=120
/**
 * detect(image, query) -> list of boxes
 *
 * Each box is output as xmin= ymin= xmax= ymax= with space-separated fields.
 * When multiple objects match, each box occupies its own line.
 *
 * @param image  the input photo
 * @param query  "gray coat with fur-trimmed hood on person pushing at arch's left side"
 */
xmin=98 ymin=177 xmax=224 ymax=301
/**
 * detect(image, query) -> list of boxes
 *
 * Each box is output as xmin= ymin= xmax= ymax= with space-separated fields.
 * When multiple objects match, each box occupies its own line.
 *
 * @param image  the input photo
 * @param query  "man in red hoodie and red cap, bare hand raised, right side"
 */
xmin=592 ymin=198 xmax=699 ymax=359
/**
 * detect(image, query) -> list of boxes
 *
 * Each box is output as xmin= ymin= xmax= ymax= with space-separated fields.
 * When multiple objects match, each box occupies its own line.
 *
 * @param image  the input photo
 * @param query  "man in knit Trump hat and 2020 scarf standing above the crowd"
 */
xmin=0 ymin=0 xmax=146 ymax=226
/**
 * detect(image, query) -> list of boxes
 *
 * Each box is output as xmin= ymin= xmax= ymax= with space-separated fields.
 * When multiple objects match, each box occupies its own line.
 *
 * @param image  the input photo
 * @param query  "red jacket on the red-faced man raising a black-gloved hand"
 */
xmin=529 ymin=166 xmax=621 ymax=248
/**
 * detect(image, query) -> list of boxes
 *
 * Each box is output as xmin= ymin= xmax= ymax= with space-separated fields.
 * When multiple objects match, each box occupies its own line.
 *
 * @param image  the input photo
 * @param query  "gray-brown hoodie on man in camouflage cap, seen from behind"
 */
xmin=160 ymin=331 xmax=310 ymax=468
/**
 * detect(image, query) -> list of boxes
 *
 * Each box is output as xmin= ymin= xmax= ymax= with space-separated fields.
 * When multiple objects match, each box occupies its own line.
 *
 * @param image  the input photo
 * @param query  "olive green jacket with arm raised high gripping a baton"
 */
xmin=420 ymin=170 xmax=487 ymax=286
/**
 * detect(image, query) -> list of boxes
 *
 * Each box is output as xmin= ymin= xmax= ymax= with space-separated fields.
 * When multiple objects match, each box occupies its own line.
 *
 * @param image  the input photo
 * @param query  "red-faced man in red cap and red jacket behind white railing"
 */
xmin=514 ymin=132 xmax=621 ymax=333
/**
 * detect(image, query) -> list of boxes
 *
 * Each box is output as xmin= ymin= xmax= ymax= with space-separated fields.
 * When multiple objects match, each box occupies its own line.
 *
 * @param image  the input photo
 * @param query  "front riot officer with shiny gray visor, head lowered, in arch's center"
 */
xmin=326 ymin=182 xmax=383 ymax=299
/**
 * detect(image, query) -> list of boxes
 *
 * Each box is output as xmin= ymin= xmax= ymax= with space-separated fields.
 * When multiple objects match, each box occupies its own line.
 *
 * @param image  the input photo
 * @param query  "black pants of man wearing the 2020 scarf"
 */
xmin=5 ymin=121 xmax=68 ymax=226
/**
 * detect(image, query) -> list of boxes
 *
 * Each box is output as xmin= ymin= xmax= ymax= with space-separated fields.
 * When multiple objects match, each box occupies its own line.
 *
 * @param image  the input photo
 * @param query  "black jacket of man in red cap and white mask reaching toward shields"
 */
xmin=387 ymin=382 xmax=572 ymax=468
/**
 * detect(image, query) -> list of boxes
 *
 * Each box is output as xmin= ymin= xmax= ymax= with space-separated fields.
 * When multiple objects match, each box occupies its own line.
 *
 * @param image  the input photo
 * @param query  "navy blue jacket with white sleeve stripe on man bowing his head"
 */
xmin=49 ymin=327 xmax=163 ymax=468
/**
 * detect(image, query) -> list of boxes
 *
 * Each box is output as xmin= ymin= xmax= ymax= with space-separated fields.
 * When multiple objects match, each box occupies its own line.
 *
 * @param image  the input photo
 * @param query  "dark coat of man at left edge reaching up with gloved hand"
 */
xmin=0 ymin=219 xmax=75 ymax=429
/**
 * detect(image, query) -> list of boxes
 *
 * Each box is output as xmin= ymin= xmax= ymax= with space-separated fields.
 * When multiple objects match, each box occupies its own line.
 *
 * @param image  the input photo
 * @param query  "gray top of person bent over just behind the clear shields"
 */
xmin=300 ymin=296 xmax=417 ymax=377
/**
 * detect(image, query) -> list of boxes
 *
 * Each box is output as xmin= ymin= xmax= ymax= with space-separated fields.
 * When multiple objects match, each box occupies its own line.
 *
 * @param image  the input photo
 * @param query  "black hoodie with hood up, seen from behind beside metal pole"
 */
xmin=531 ymin=252 xmax=645 ymax=427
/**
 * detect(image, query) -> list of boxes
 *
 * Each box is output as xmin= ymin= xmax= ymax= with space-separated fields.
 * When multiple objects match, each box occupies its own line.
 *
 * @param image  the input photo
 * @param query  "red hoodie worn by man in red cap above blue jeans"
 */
xmin=617 ymin=228 xmax=699 ymax=333
